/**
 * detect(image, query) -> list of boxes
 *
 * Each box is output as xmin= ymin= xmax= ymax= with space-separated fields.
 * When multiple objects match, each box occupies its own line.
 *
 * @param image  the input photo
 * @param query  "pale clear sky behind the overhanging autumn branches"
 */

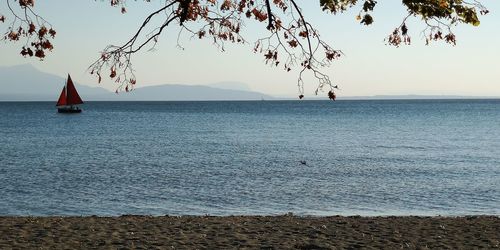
xmin=0 ymin=0 xmax=500 ymax=97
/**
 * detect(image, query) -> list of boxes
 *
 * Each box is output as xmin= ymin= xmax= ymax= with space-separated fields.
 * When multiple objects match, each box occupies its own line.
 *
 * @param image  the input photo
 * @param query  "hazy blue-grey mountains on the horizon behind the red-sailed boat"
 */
xmin=0 ymin=64 xmax=273 ymax=101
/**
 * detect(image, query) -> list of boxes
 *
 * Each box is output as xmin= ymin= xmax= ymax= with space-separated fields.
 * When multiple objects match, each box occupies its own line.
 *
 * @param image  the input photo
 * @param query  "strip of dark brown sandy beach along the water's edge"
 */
xmin=0 ymin=215 xmax=500 ymax=249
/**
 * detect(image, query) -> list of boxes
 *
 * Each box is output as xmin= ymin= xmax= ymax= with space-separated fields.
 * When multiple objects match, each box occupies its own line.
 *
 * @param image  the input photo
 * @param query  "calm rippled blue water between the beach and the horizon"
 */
xmin=0 ymin=100 xmax=500 ymax=215
